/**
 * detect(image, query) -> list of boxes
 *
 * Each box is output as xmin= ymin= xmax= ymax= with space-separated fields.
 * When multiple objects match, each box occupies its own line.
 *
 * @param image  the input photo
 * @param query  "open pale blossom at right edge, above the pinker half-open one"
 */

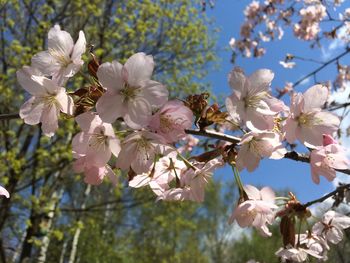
xmin=283 ymin=85 xmax=340 ymax=146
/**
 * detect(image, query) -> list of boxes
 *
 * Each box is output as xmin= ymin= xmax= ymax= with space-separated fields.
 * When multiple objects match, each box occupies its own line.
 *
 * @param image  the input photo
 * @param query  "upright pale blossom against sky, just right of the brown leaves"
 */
xmin=226 ymin=68 xmax=285 ymax=130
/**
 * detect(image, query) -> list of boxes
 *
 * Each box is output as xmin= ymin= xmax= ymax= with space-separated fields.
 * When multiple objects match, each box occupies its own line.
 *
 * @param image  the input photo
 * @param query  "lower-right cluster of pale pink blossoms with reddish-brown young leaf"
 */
xmin=229 ymin=185 xmax=350 ymax=262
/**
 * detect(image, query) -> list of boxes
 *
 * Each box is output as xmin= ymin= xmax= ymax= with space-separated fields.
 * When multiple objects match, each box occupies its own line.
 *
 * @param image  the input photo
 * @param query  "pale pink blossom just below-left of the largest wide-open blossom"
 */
xmin=72 ymin=112 xmax=120 ymax=167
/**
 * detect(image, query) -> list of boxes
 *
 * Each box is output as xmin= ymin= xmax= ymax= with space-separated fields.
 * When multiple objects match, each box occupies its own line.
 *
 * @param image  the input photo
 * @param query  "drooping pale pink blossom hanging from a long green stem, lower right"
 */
xmin=229 ymin=185 xmax=277 ymax=236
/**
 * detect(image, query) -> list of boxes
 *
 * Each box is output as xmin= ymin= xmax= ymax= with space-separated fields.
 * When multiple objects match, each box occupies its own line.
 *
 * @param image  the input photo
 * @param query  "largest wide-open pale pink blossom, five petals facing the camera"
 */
xmin=96 ymin=53 xmax=168 ymax=129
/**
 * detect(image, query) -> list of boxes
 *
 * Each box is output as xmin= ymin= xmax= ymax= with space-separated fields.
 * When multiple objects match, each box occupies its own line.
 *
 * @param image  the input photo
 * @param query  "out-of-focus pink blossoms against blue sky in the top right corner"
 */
xmin=229 ymin=0 xmax=350 ymax=62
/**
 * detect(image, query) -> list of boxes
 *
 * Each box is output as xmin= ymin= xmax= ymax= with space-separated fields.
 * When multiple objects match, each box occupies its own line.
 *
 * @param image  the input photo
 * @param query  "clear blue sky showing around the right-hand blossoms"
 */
xmin=207 ymin=0 xmax=349 ymax=202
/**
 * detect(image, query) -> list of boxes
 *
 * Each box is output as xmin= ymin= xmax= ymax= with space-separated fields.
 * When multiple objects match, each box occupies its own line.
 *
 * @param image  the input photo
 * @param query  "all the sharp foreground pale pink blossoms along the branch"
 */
xmin=10 ymin=24 xmax=350 ymax=259
